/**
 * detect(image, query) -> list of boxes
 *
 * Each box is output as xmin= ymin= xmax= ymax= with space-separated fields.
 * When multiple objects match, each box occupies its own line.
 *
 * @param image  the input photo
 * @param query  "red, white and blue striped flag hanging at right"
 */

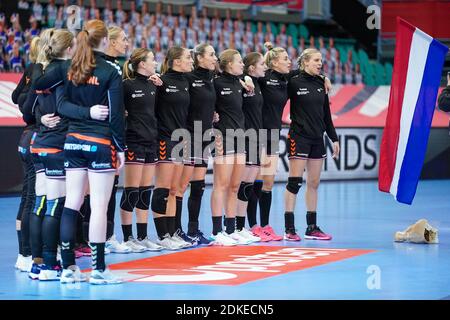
xmin=378 ymin=18 xmax=448 ymax=204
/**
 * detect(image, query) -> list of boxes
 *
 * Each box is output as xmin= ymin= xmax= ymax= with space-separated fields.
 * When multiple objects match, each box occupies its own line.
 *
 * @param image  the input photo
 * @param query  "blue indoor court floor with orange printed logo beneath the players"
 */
xmin=0 ymin=180 xmax=450 ymax=300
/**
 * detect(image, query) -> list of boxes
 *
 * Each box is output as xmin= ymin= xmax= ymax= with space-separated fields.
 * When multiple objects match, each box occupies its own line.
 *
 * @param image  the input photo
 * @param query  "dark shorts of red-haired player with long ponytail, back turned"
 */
xmin=64 ymin=133 xmax=117 ymax=171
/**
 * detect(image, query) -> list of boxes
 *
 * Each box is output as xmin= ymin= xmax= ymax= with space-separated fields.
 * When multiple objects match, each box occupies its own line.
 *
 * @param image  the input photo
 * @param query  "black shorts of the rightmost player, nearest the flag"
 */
xmin=288 ymin=133 xmax=327 ymax=160
